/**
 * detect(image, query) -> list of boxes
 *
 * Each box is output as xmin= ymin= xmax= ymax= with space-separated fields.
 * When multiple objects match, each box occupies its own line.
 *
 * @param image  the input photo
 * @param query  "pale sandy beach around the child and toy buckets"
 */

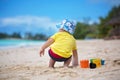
xmin=0 ymin=40 xmax=120 ymax=80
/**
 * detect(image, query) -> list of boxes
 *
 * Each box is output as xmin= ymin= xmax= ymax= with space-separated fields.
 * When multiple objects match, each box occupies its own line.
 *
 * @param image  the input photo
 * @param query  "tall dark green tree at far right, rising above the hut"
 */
xmin=98 ymin=5 xmax=120 ymax=38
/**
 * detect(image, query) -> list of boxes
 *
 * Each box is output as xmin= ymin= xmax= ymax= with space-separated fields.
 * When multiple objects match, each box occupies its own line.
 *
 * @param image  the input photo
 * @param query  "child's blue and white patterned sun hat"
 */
xmin=56 ymin=19 xmax=75 ymax=34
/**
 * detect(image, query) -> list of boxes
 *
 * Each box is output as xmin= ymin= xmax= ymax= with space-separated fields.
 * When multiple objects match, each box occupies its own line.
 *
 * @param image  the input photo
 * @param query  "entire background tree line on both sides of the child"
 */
xmin=0 ymin=5 xmax=120 ymax=40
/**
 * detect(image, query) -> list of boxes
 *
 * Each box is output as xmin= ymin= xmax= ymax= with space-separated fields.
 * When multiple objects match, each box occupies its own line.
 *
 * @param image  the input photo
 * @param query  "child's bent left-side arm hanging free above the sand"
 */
xmin=40 ymin=38 xmax=54 ymax=56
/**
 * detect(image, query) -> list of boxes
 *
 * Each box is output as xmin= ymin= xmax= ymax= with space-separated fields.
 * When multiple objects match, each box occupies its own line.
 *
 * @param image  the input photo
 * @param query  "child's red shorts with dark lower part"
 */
xmin=49 ymin=49 xmax=72 ymax=62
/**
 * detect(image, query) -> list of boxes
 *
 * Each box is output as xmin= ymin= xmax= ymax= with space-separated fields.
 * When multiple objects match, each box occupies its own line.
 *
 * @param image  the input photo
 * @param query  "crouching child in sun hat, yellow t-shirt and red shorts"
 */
xmin=40 ymin=19 xmax=78 ymax=68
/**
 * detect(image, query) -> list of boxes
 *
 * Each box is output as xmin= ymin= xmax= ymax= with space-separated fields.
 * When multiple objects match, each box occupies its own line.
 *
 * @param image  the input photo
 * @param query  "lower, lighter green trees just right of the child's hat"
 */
xmin=73 ymin=22 xmax=98 ymax=39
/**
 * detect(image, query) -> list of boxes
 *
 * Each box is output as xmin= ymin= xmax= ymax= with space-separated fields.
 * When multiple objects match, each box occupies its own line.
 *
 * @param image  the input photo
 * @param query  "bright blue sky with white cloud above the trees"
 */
xmin=0 ymin=0 xmax=120 ymax=35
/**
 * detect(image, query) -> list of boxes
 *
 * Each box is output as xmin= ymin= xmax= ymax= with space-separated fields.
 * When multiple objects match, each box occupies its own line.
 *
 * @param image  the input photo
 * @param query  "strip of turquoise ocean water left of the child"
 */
xmin=0 ymin=39 xmax=45 ymax=48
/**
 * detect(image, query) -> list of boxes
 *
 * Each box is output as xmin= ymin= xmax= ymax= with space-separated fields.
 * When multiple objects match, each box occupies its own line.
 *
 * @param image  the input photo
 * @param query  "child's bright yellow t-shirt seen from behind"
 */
xmin=50 ymin=32 xmax=76 ymax=58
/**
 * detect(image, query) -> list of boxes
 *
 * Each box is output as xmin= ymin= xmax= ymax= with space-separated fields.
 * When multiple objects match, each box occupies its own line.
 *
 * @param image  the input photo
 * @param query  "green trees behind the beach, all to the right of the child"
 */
xmin=73 ymin=5 xmax=120 ymax=39
